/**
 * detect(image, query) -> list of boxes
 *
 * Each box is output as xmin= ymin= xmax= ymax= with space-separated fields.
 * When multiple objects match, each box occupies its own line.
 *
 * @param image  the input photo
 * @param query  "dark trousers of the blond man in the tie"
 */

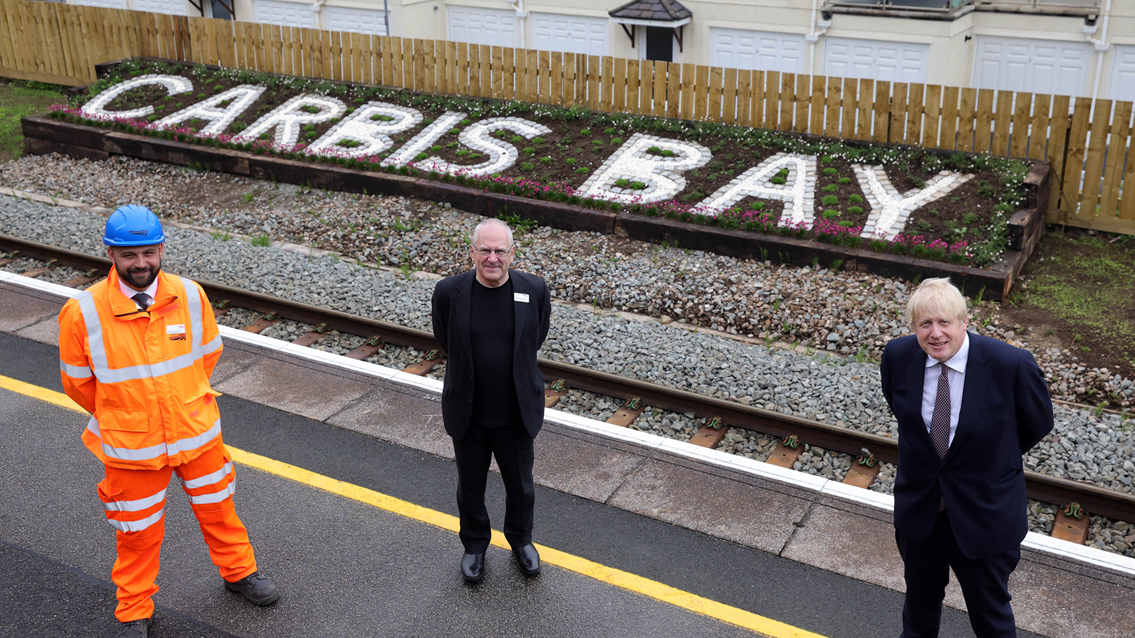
xmin=894 ymin=512 xmax=1020 ymax=638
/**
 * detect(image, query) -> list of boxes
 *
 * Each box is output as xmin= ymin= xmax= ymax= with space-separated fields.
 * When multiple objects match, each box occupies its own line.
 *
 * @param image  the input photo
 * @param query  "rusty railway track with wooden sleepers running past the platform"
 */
xmin=0 ymin=230 xmax=1135 ymax=533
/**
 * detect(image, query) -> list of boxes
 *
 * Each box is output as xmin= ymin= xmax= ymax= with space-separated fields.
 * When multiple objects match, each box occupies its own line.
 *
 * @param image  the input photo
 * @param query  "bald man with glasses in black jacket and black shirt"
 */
xmin=432 ymin=219 xmax=552 ymax=582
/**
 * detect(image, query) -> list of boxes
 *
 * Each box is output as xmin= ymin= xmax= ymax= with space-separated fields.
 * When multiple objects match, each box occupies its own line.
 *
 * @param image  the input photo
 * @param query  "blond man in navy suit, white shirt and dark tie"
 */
xmin=881 ymin=278 xmax=1052 ymax=638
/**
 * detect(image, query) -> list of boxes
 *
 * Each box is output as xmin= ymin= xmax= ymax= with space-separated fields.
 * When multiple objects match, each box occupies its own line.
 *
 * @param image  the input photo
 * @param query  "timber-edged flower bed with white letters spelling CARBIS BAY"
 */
xmin=25 ymin=55 xmax=1048 ymax=296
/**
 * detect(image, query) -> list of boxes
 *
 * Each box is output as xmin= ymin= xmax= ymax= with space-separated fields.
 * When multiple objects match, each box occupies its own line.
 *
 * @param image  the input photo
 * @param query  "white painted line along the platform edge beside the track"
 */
xmin=8 ymin=263 xmax=1135 ymax=577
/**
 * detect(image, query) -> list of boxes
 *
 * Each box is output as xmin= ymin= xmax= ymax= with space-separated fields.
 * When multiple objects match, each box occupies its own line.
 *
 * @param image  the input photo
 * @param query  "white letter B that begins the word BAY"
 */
xmin=579 ymin=133 xmax=712 ymax=203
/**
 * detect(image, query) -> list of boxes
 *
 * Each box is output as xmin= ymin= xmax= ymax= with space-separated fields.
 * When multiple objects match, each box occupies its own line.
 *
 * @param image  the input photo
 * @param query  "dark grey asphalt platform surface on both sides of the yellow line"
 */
xmin=0 ymin=333 xmax=1032 ymax=638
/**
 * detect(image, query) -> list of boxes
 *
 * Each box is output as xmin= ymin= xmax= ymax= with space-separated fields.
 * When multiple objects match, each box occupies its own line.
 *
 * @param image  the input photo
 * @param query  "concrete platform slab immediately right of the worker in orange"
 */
xmin=213 ymin=359 xmax=371 ymax=421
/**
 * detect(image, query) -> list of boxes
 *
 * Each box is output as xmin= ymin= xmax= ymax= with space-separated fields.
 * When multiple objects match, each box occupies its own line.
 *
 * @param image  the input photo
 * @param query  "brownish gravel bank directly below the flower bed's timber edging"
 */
xmin=0 ymin=156 xmax=1135 ymax=410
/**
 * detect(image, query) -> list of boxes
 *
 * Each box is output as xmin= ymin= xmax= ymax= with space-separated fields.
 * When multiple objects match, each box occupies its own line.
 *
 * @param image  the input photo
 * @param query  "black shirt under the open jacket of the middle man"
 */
xmin=469 ymin=278 xmax=521 ymax=428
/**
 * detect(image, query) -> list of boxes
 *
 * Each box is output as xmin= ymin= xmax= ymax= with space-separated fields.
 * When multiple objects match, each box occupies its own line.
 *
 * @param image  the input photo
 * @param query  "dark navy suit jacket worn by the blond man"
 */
xmin=881 ymin=333 xmax=1052 ymax=559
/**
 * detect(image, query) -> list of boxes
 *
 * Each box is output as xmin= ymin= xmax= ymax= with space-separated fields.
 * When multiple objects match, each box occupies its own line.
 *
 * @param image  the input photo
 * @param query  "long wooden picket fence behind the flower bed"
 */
xmin=0 ymin=0 xmax=1135 ymax=234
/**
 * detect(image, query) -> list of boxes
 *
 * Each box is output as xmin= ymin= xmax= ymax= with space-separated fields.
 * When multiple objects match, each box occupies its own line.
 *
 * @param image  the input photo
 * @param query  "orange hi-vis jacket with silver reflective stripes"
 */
xmin=59 ymin=269 xmax=221 ymax=470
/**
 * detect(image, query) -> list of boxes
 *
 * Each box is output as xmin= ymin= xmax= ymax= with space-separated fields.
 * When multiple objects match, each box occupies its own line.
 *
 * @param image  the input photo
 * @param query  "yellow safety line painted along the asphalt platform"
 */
xmin=0 ymin=376 xmax=824 ymax=638
